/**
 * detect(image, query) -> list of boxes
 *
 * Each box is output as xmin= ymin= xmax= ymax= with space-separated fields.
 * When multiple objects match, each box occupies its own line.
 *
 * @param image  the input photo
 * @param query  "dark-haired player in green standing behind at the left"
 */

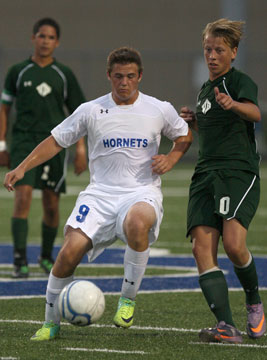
xmin=0 ymin=18 xmax=87 ymax=277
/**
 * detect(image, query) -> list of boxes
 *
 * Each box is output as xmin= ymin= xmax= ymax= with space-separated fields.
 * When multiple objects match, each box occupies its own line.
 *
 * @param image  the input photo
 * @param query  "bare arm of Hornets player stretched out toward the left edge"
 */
xmin=4 ymin=135 xmax=62 ymax=191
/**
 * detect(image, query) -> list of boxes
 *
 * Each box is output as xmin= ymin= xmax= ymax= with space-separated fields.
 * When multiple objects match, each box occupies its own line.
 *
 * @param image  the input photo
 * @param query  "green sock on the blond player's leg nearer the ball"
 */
xmin=199 ymin=271 xmax=235 ymax=326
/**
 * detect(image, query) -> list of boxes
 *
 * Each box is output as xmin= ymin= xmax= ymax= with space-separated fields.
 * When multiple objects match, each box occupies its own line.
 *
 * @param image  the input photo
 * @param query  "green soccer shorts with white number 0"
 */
xmin=187 ymin=170 xmax=260 ymax=236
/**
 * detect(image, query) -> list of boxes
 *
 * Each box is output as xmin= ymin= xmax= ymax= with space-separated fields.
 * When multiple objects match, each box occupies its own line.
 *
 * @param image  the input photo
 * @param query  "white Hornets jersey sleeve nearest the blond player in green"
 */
xmin=162 ymin=102 xmax=188 ymax=141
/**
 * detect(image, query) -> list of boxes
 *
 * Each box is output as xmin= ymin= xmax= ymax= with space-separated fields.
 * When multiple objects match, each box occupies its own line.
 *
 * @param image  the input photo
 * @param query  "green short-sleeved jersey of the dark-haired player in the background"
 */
xmin=1 ymin=59 xmax=85 ymax=134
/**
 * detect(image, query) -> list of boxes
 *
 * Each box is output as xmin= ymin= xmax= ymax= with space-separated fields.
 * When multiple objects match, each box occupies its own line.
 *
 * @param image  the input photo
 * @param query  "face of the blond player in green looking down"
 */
xmin=204 ymin=34 xmax=237 ymax=80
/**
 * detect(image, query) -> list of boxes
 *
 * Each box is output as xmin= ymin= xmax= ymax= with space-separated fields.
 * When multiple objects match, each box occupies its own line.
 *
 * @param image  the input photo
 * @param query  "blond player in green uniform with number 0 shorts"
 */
xmin=181 ymin=19 xmax=266 ymax=343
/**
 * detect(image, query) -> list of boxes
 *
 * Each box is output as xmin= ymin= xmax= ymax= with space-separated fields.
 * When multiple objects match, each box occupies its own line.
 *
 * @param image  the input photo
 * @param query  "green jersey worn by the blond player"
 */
xmin=196 ymin=68 xmax=260 ymax=175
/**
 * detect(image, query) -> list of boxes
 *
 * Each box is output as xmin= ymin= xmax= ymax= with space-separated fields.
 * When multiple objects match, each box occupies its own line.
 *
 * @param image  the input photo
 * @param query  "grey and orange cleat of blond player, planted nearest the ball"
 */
xmin=199 ymin=321 xmax=243 ymax=344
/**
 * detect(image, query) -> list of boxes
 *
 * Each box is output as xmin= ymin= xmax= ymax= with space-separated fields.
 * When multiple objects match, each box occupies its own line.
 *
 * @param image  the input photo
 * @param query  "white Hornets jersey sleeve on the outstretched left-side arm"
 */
xmin=51 ymin=105 xmax=88 ymax=148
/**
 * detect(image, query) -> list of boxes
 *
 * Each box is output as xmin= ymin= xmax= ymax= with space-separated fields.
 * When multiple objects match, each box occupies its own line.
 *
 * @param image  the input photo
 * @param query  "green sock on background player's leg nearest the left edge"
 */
xmin=11 ymin=217 xmax=28 ymax=265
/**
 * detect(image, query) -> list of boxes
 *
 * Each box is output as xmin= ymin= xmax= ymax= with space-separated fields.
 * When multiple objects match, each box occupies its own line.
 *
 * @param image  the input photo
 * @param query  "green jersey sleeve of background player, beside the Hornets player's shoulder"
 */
xmin=65 ymin=68 xmax=86 ymax=114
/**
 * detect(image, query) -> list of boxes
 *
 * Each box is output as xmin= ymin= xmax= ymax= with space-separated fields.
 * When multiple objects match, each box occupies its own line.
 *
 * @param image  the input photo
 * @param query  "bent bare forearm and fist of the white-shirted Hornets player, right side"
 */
xmin=151 ymin=129 xmax=193 ymax=175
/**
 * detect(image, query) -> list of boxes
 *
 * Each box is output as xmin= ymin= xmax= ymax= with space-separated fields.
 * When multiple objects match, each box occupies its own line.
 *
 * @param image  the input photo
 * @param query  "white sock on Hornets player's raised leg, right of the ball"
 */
xmin=121 ymin=245 xmax=150 ymax=300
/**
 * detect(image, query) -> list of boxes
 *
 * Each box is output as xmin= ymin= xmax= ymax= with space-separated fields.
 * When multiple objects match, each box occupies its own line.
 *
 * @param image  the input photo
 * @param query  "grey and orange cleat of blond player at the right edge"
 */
xmin=246 ymin=303 xmax=266 ymax=339
